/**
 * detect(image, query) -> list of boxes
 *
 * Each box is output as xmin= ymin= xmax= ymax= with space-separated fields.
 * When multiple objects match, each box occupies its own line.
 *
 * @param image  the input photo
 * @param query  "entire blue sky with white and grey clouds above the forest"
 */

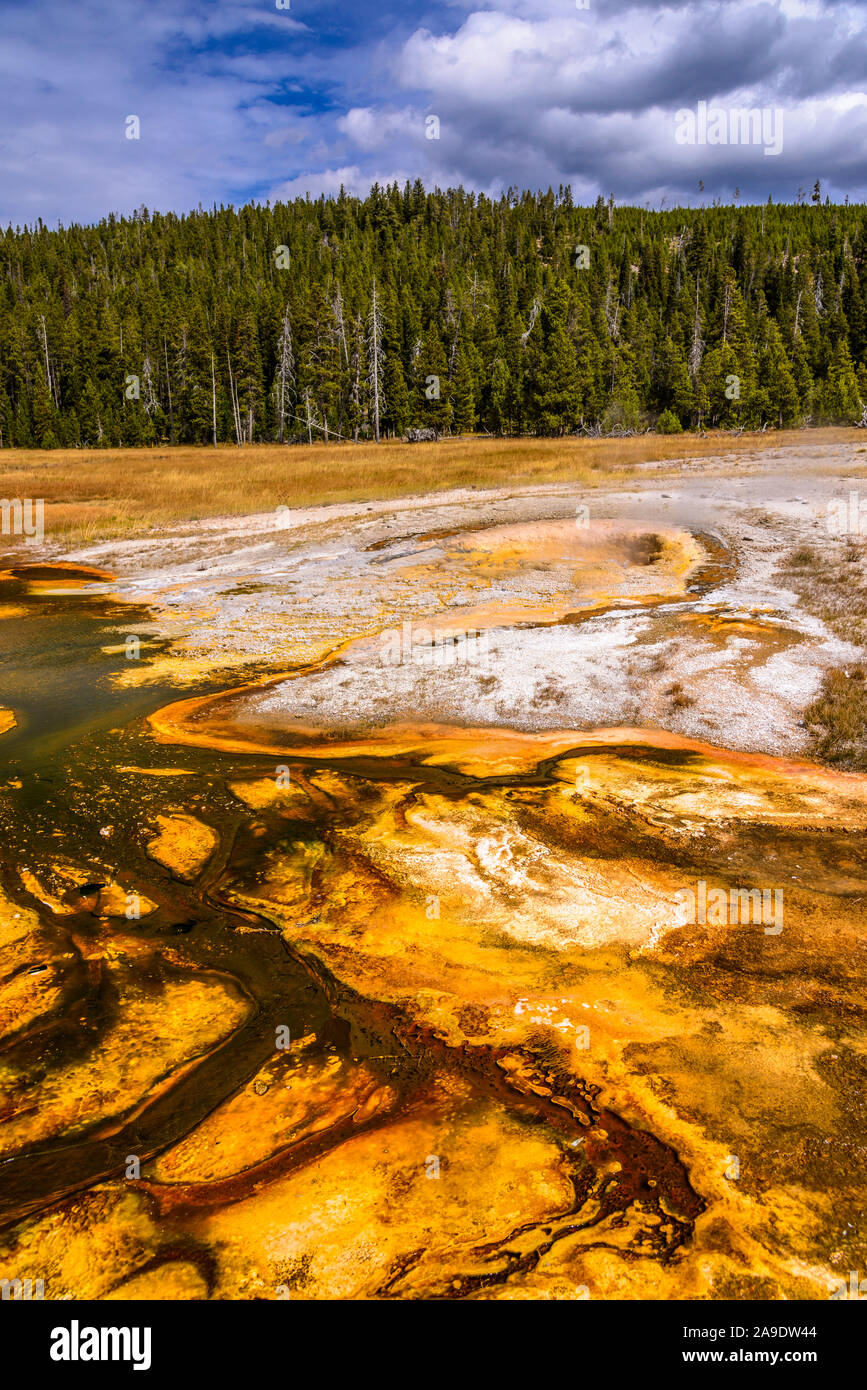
xmin=0 ymin=0 xmax=867 ymax=225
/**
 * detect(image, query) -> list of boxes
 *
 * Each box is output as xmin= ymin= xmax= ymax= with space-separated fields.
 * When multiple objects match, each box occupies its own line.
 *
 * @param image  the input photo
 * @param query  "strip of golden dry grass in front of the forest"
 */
xmin=0 ymin=428 xmax=864 ymax=545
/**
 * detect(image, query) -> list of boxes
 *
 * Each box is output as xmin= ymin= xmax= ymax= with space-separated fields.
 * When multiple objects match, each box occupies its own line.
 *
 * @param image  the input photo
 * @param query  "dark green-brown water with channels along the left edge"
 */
xmin=0 ymin=564 xmax=364 ymax=1225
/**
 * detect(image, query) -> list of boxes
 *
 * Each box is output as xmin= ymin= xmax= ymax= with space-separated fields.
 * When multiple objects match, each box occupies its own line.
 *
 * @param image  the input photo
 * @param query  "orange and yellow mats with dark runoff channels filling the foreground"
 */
xmin=0 ymin=530 xmax=867 ymax=1298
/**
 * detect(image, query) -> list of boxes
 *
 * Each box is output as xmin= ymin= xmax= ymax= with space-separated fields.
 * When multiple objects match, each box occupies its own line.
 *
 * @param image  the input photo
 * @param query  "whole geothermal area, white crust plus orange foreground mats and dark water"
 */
xmin=0 ymin=447 xmax=867 ymax=1300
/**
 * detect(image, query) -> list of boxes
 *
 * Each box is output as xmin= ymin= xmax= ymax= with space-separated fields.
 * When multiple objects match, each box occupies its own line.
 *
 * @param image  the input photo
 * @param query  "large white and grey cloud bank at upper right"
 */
xmin=341 ymin=0 xmax=867 ymax=202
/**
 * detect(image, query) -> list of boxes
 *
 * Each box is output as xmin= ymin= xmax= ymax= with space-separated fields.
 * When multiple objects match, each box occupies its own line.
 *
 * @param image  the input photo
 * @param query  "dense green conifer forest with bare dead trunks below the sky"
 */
xmin=0 ymin=181 xmax=867 ymax=449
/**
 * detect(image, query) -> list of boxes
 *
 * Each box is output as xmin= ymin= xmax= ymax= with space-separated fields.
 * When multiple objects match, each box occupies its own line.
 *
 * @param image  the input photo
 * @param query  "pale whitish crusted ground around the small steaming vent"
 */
xmin=55 ymin=445 xmax=867 ymax=753
